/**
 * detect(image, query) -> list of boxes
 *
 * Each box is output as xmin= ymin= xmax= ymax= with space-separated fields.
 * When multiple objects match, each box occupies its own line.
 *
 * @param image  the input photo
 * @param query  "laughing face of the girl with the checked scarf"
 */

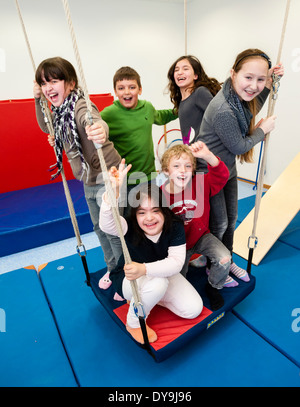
xmin=41 ymin=76 xmax=75 ymax=107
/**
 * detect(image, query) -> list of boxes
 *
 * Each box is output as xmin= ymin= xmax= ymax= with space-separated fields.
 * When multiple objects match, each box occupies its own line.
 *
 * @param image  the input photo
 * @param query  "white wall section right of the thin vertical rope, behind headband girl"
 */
xmin=187 ymin=0 xmax=300 ymax=185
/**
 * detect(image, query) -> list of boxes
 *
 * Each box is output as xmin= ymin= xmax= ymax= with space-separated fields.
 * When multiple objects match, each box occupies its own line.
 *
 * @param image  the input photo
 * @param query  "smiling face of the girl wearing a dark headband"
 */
xmin=231 ymin=58 xmax=268 ymax=102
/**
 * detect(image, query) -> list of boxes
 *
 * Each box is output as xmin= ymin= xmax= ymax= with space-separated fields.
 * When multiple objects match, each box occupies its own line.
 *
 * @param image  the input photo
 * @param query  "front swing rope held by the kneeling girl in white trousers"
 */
xmin=62 ymin=0 xmax=146 ymax=312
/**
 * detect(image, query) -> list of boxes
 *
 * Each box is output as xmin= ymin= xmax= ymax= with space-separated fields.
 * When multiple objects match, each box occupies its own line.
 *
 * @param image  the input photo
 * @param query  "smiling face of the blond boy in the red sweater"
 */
xmin=165 ymin=153 xmax=194 ymax=194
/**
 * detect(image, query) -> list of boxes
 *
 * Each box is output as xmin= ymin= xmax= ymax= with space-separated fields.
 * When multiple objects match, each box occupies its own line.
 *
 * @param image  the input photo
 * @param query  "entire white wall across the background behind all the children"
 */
xmin=0 ymin=0 xmax=300 ymax=184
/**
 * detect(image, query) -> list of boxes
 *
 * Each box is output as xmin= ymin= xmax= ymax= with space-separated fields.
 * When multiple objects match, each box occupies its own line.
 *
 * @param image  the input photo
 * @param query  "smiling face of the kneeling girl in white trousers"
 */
xmin=136 ymin=197 xmax=164 ymax=236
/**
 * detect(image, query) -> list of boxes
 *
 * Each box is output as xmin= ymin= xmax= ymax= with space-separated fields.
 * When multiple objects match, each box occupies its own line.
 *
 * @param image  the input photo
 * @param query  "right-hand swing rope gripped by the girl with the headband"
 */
xmin=247 ymin=0 xmax=291 ymax=272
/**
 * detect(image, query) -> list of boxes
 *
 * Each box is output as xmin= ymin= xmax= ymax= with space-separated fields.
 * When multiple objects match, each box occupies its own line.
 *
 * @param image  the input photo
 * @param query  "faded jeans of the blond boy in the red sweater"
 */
xmin=181 ymin=233 xmax=231 ymax=289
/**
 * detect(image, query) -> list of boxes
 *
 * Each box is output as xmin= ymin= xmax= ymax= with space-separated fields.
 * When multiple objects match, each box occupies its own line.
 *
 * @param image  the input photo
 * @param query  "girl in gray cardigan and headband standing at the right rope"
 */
xmin=196 ymin=49 xmax=284 ymax=281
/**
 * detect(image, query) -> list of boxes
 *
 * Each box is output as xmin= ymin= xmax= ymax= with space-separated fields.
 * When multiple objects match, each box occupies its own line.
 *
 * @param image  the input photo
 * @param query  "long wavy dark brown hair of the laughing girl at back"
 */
xmin=168 ymin=55 xmax=221 ymax=111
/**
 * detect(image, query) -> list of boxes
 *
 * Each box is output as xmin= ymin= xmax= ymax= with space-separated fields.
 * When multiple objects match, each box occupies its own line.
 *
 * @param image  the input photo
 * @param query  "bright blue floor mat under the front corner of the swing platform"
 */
xmin=40 ymin=249 xmax=299 ymax=387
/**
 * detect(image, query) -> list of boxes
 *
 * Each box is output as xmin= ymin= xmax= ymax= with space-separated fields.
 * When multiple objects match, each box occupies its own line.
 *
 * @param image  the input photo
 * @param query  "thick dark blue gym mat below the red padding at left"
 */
xmin=0 ymin=180 xmax=93 ymax=257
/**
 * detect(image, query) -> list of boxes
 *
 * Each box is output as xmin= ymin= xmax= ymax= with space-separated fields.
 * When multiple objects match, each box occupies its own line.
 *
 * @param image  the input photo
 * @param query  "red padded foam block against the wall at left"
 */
xmin=0 ymin=93 xmax=114 ymax=193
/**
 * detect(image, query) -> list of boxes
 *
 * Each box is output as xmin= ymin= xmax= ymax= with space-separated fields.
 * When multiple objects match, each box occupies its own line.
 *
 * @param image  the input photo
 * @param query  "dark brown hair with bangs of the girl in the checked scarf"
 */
xmin=35 ymin=57 xmax=78 ymax=89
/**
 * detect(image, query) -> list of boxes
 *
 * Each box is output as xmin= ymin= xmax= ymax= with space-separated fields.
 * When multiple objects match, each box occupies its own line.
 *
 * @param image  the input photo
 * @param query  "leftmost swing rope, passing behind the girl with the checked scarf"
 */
xmin=15 ymin=0 xmax=90 ymax=285
